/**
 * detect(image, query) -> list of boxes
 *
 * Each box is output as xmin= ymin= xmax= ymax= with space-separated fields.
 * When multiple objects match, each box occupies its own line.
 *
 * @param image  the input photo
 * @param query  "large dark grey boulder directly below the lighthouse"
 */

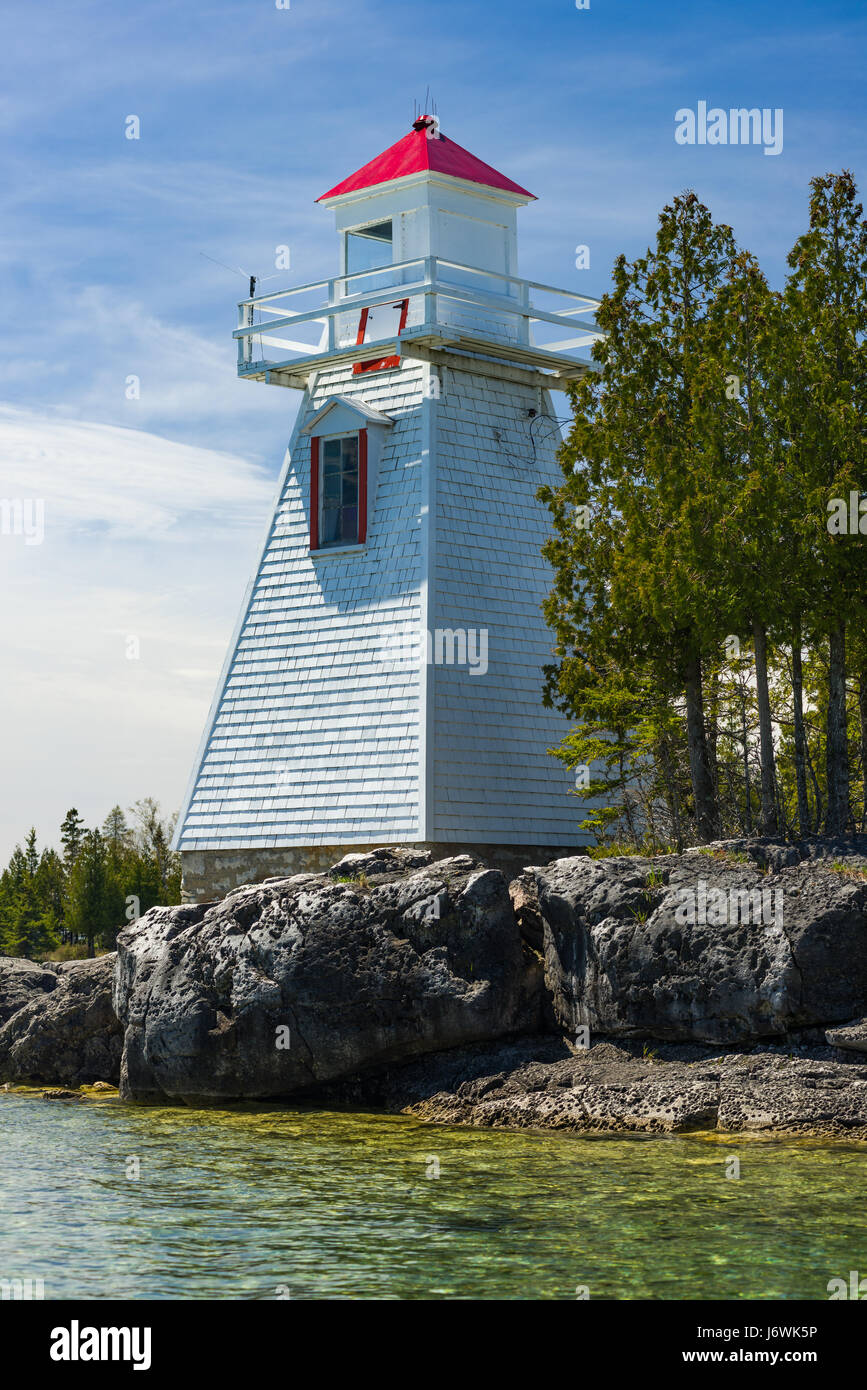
xmin=115 ymin=851 xmax=542 ymax=1101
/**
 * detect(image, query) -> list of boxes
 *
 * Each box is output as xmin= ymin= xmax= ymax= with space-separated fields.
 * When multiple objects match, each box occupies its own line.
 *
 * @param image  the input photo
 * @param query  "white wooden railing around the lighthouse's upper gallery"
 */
xmin=235 ymin=256 xmax=602 ymax=375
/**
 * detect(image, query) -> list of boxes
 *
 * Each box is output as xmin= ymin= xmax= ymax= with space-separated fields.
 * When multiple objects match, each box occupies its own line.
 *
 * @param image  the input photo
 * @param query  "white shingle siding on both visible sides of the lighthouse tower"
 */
xmin=176 ymin=361 xmax=581 ymax=851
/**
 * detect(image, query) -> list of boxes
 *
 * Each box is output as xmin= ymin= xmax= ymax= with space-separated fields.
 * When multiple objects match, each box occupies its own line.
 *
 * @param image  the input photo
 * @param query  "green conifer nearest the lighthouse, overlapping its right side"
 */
xmin=539 ymin=193 xmax=735 ymax=841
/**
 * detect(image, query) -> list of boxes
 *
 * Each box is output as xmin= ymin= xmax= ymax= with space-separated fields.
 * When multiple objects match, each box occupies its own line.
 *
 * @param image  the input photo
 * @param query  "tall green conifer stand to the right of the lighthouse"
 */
xmin=539 ymin=171 xmax=867 ymax=852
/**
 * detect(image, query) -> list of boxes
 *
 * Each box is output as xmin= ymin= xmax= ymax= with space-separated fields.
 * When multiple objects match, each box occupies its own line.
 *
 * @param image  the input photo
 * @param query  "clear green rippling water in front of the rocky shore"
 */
xmin=0 ymin=1093 xmax=867 ymax=1300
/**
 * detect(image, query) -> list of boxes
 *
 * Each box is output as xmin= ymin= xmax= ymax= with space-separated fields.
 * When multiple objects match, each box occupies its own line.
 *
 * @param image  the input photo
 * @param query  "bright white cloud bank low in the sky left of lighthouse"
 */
xmin=0 ymin=407 xmax=275 ymax=859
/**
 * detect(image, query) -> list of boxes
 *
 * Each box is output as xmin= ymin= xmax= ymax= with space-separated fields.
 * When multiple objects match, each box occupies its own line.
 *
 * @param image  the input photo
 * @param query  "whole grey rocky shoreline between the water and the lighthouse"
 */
xmin=0 ymin=837 xmax=867 ymax=1141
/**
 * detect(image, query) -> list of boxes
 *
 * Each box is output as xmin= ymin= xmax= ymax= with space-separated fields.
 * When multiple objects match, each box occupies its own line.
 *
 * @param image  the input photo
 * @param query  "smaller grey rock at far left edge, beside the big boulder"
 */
xmin=0 ymin=955 xmax=122 ymax=1086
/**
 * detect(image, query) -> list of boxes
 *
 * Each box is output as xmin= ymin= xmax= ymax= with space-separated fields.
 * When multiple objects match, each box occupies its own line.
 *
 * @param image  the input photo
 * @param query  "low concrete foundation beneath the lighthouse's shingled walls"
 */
xmin=181 ymin=840 xmax=586 ymax=902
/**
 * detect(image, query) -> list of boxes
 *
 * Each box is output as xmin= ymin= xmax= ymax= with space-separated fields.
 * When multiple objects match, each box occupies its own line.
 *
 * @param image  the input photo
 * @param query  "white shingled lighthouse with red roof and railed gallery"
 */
xmin=174 ymin=115 xmax=599 ymax=901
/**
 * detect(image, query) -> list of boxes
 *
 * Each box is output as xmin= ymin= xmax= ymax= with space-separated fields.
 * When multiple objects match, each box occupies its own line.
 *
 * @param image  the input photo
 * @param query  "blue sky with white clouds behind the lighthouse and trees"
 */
xmin=0 ymin=0 xmax=867 ymax=862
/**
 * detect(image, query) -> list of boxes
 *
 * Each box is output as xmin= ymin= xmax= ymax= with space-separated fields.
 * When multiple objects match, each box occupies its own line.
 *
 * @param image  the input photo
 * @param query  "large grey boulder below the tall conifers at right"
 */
xmin=534 ymin=847 xmax=867 ymax=1044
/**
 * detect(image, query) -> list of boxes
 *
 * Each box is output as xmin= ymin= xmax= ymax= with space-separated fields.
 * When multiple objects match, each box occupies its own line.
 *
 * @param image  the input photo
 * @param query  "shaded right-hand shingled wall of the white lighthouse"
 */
xmin=429 ymin=370 xmax=582 ymax=845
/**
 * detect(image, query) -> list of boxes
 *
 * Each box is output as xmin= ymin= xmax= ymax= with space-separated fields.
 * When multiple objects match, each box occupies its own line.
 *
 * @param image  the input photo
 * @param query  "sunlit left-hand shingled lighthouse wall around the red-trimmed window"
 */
xmin=178 ymin=364 xmax=424 ymax=851
